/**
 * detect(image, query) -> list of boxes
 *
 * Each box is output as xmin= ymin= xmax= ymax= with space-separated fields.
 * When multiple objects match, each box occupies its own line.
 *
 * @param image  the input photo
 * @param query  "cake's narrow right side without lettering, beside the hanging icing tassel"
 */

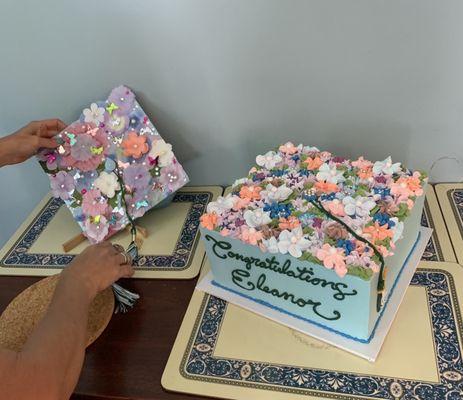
xmin=369 ymin=189 xmax=425 ymax=334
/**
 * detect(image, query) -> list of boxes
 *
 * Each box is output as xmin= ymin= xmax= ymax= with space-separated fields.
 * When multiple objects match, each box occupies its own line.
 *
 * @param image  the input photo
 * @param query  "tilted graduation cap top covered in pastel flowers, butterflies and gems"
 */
xmin=38 ymin=86 xmax=188 ymax=243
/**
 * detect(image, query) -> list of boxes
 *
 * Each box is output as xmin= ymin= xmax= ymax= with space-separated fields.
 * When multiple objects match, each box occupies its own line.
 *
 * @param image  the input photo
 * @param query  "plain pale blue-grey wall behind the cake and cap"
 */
xmin=0 ymin=0 xmax=463 ymax=247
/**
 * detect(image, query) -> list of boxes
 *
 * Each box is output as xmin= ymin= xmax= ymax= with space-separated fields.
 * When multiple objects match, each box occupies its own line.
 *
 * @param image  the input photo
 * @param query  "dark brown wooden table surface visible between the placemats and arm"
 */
xmin=0 ymin=277 xmax=207 ymax=400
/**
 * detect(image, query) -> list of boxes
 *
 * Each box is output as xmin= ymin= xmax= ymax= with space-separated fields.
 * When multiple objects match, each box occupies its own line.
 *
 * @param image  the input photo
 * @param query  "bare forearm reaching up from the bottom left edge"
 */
xmin=3 ymin=273 xmax=93 ymax=400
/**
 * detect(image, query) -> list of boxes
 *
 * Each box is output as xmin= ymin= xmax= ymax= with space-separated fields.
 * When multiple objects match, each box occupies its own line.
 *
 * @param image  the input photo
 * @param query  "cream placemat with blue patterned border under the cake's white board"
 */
xmin=162 ymin=261 xmax=463 ymax=400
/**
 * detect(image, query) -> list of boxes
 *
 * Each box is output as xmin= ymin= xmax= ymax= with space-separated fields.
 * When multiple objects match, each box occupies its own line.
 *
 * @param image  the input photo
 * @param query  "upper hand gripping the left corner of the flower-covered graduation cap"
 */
xmin=0 ymin=119 xmax=66 ymax=166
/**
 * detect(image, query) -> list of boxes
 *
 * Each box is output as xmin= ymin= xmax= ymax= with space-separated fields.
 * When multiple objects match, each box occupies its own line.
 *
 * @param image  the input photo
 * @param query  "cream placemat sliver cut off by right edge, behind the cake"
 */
xmin=436 ymin=183 xmax=463 ymax=264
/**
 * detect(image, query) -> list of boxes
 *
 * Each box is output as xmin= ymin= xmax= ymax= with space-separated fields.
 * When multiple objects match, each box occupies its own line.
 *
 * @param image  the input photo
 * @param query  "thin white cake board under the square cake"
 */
xmin=196 ymin=227 xmax=432 ymax=361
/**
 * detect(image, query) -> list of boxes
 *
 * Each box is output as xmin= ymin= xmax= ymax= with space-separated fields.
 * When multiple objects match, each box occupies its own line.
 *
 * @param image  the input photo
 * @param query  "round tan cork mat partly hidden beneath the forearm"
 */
xmin=0 ymin=274 xmax=115 ymax=351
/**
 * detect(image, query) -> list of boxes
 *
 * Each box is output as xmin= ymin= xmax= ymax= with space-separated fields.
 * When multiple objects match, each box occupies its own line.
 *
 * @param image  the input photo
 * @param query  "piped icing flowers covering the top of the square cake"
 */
xmin=201 ymin=142 xmax=427 ymax=279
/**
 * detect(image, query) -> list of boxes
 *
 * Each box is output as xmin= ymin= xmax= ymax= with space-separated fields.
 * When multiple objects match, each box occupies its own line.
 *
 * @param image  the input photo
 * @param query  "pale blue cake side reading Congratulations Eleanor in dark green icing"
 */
xmin=201 ymin=228 xmax=371 ymax=340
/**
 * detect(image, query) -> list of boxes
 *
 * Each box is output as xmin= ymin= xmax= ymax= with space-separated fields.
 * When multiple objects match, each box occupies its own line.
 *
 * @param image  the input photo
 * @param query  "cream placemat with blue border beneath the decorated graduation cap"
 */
xmin=0 ymin=186 xmax=223 ymax=279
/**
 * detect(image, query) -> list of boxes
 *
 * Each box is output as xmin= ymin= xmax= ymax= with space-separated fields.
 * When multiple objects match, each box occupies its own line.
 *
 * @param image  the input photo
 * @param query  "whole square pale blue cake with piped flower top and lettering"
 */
xmin=201 ymin=142 xmax=427 ymax=343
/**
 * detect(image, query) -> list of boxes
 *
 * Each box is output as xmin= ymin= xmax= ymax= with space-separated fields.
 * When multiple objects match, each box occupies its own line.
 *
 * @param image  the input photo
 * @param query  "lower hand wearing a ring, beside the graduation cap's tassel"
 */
xmin=62 ymin=242 xmax=134 ymax=298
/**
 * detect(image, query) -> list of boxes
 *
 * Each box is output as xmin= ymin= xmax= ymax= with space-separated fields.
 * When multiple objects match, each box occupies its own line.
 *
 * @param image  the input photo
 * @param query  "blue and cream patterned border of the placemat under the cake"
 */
xmin=179 ymin=268 xmax=463 ymax=400
